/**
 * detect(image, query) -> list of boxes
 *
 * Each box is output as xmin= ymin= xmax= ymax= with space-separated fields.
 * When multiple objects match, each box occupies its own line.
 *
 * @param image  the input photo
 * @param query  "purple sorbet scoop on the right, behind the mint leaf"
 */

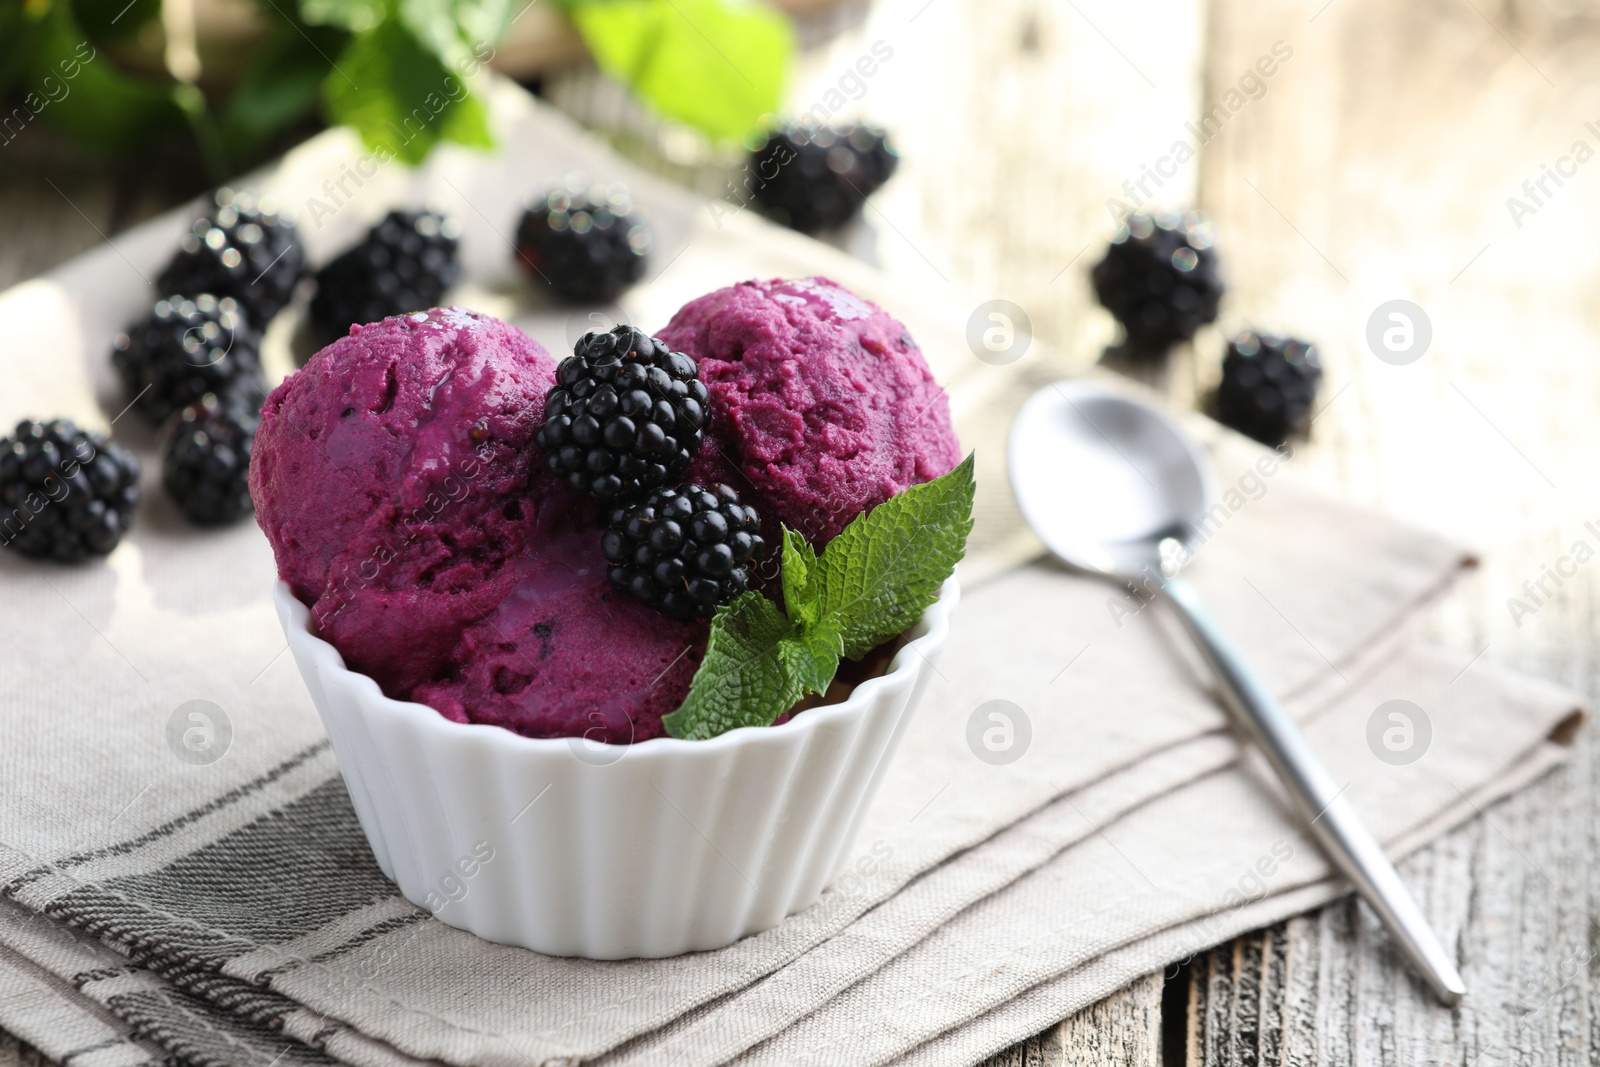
xmin=661 ymin=278 xmax=962 ymax=545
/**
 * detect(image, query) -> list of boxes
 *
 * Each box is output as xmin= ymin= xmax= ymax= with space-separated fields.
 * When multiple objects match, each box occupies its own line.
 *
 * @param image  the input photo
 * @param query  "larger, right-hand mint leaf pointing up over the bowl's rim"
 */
xmin=818 ymin=453 xmax=976 ymax=659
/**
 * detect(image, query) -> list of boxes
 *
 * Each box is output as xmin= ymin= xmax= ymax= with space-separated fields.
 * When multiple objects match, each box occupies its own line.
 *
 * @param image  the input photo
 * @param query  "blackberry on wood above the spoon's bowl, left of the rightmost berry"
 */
xmin=1093 ymin=213 xmax=1222 ymax=354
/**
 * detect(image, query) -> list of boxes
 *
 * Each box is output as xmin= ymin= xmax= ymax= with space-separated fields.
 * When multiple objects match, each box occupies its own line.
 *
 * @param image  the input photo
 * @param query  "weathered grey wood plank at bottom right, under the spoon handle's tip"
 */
xmin=1186 ymin=752 xmax=1595 ymax=1065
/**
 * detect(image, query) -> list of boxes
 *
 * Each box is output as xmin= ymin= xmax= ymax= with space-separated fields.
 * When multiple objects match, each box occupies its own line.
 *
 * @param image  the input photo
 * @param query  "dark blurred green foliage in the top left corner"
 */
xmin=0 ymin=0 xmax=510 ymax=171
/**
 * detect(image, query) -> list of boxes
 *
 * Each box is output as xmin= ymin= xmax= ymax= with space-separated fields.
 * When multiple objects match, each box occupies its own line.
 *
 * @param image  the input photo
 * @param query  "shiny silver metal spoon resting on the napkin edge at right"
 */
xmin=1010 ymin=382 xmax=1466 ymax=1005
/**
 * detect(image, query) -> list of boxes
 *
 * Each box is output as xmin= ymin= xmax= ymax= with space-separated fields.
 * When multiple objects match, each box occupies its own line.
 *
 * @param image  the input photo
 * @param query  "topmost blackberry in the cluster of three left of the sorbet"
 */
xmin=155 ymin=189 xmax=306 ymax=330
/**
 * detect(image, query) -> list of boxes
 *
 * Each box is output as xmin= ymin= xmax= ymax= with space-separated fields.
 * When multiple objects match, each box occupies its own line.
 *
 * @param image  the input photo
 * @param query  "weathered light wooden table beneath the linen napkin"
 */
xmin=0 ymin=0 xmax=1600 ymax=1067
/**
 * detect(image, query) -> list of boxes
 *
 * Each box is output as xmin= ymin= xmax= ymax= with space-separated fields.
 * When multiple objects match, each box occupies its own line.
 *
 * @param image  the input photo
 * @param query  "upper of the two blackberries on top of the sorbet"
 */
xmin=534 ymin=326 xmax=707 ymax=502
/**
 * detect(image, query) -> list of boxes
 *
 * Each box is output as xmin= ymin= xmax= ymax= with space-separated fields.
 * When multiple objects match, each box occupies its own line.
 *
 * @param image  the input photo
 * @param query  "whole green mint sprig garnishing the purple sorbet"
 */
xmin=661 ymin=454 xmax=974 ymax=741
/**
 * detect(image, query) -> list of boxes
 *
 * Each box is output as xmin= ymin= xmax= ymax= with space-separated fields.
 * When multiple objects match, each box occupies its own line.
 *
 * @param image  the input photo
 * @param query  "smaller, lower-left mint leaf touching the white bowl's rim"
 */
xmin=661 ymin=590 xmax=803 ymax=739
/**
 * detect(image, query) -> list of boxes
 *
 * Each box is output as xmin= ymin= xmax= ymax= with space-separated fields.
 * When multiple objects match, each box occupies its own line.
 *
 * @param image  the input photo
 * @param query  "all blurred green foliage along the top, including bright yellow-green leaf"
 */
xmin=0 ymin=0 xmax=794 ymax=181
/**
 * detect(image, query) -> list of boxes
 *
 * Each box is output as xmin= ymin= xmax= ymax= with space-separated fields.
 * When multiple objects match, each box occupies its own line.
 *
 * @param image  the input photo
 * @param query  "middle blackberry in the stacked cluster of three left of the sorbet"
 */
xmin=110 ymin=293 xmax=266 ymax=426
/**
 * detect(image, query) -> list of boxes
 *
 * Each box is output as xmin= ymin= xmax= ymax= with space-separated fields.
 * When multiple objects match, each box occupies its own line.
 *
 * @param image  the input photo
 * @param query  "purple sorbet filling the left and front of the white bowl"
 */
xmin=250 ymin=309 xmax=706 ymax=742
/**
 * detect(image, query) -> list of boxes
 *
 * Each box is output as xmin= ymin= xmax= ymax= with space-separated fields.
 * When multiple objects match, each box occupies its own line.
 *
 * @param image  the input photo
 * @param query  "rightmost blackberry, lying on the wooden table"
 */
xmin=1216 ymin=333 xmax=1322 ymax=446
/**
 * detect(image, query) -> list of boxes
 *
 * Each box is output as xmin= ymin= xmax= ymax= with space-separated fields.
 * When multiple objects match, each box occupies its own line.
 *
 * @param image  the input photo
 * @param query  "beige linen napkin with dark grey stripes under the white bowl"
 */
xmin=0 ymin=83 xmax=1576 ymax=1064
